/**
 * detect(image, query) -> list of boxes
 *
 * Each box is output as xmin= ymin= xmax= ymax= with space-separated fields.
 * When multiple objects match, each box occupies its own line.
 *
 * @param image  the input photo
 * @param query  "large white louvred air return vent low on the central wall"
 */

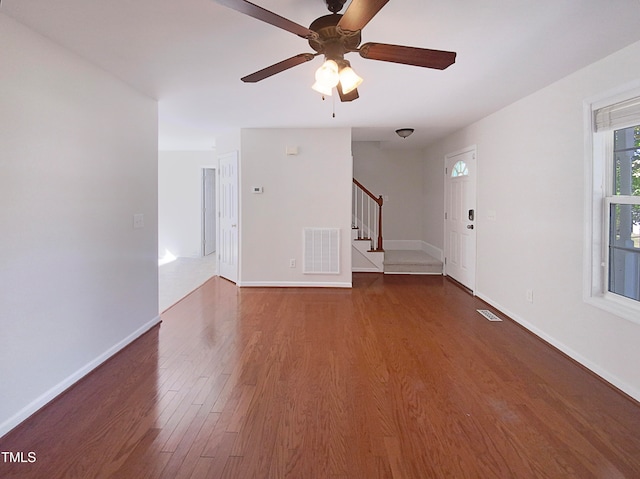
xmin=303 ymin=228 xmax=340 ymax=274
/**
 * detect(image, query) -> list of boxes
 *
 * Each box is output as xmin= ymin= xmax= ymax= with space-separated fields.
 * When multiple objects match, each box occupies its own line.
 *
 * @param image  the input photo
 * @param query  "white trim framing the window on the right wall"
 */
xmin=583 ymin=81 xmax=640 ymax=324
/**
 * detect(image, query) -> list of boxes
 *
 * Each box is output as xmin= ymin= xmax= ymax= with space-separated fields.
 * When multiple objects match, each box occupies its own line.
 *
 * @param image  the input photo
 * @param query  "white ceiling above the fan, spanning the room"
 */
xmin=5 ymin=0 xmax=640 ymax=149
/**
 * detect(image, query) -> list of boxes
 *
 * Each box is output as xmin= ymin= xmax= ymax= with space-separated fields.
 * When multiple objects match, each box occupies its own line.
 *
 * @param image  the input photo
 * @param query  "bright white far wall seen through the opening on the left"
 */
xmin=158 ymin=150 xmax=217 ymax=257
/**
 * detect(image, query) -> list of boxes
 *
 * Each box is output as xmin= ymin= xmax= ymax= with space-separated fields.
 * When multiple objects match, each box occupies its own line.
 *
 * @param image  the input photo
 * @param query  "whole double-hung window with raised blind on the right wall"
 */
xmin=587 ymin=91 xmax=640 ymax=322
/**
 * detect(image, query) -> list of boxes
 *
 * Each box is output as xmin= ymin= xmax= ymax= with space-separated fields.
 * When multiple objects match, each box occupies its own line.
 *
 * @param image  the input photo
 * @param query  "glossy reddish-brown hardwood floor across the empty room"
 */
xmin=0 ymin=274 xmax=640 ymax=479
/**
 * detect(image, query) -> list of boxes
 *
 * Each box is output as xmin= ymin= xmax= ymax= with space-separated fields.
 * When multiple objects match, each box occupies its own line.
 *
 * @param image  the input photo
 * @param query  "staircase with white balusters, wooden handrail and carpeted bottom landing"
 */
xmin=351 ymin=178 xmax=443 ymax=274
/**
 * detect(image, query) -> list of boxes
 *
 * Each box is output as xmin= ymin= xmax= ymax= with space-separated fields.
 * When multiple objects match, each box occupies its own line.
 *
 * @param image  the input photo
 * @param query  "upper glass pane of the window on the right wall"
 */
xmin=613 ymin=125 xmax=640 ymax=196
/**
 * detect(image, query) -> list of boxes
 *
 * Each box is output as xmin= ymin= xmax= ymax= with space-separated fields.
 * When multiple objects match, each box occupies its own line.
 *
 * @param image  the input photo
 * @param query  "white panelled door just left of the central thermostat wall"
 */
xmin=218 ymin=152 xmax=238 ymax=283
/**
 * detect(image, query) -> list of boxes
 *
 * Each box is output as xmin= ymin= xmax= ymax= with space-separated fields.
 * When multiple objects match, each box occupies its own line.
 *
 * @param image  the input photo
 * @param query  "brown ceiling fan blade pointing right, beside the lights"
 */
xmin=359 ymin=43 xmax=456 ymax=70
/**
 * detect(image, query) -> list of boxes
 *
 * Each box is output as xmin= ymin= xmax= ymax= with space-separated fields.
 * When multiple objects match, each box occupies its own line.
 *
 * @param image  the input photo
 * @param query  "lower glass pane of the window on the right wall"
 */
xmin=609 ymin=204 xmax=640 ymax=301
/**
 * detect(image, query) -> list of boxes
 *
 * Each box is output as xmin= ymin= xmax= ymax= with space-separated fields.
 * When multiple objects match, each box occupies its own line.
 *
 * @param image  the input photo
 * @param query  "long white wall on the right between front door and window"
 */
xmin=427 ymin=43 xmax=640 ymax=399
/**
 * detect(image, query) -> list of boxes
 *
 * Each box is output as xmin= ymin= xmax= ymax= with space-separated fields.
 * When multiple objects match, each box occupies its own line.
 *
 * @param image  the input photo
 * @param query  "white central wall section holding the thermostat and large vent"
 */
xmin=239 ymin=128 xmax=353 ymax=287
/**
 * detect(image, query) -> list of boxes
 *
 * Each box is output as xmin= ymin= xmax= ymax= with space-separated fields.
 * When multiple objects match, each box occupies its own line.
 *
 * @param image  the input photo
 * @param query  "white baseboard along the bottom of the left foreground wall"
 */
xmin=0 ymin=316 xmax=160 ymax=437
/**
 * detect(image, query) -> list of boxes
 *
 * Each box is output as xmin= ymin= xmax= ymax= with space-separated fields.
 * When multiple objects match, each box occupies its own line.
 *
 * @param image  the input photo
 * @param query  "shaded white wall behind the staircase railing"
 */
xmin=353 ymin=142 xmax=424 ymax=249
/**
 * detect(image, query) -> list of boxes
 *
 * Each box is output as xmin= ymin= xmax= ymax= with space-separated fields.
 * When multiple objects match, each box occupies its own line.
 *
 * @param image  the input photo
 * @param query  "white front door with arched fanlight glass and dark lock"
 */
xmin=444 ymin=147 xmax=477 ymax=291
